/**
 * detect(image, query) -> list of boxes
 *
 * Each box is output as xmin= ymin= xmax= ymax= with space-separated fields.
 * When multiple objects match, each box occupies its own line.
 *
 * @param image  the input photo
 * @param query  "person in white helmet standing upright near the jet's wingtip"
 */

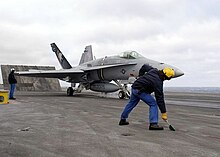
xmin=8 ymin=68 xmax=17 ymax=100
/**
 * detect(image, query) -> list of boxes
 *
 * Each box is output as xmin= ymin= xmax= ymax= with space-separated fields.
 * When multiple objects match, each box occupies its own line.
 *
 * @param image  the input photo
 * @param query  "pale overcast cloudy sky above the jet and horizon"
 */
xmin=0 ymin=0 xmax=220 ymax=87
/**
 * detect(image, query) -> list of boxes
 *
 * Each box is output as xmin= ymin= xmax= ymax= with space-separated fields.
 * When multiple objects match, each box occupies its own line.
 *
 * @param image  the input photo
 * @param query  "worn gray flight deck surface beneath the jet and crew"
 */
xmin=0 ymin=92 xmax=220 ymax=157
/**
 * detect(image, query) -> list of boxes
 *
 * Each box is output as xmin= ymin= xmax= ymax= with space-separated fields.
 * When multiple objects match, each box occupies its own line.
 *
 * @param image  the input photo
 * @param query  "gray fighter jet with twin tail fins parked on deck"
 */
xmin=16 ymin=43 xmax=184 ymax=99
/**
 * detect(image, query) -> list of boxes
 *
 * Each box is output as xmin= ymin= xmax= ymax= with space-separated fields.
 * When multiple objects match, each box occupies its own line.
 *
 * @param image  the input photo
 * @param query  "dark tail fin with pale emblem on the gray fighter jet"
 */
xmin=50 ymin=43 xmax=72 ymax=69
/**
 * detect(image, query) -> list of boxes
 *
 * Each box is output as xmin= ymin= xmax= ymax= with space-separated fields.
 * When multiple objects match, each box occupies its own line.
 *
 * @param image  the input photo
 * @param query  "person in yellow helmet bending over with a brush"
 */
xmin=119 ymin=64 xmax=174 ymax=130
